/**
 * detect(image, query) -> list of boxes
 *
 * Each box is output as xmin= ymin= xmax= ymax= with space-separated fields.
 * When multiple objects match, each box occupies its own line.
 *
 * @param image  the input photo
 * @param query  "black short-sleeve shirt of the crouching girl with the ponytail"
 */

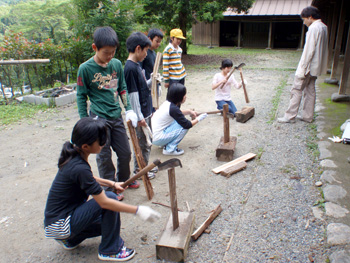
xmin=44 ymin=155 xmax=103 ymax=226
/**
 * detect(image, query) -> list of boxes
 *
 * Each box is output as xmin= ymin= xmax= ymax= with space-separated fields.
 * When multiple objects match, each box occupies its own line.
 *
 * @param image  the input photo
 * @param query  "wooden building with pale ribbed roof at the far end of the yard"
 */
xmin=192 ymin=0 xmax=312 ymax=49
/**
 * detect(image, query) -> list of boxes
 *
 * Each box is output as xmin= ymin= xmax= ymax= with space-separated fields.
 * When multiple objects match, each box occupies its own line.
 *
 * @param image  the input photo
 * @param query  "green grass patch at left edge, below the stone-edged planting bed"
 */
xmin=0 ymin=102 xmax=49 ymax=126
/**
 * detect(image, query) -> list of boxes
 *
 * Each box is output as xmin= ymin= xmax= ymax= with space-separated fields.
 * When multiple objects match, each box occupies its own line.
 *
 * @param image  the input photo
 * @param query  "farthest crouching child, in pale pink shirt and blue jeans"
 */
xmin=212 ymin=59 xmax=242 ymax=116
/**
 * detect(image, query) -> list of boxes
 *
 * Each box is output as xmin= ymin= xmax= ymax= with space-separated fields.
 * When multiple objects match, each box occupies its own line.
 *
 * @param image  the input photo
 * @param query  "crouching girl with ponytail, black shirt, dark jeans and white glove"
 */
xmin=44 ymin=117 xmax=160 ymax=261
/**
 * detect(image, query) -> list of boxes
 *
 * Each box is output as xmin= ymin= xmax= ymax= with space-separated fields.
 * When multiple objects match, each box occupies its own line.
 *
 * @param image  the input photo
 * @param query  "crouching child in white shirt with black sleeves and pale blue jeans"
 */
xmin=152 ymin=83 xmax=207 ymax=155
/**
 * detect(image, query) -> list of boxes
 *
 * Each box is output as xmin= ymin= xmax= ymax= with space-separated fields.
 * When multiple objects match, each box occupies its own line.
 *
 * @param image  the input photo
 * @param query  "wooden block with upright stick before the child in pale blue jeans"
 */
xmin=216 ymin=104 xmax=237 ymax=162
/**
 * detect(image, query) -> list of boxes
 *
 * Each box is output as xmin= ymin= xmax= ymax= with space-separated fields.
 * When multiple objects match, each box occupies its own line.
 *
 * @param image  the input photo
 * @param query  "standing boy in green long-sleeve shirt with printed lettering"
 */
xmin=77 ymin=27 xmax=139 ymax=200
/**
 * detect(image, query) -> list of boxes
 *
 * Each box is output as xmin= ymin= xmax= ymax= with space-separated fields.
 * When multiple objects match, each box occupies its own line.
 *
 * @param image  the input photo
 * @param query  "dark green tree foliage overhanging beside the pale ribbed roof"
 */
xmin=138 ymin=0 xmax=254 ymax=54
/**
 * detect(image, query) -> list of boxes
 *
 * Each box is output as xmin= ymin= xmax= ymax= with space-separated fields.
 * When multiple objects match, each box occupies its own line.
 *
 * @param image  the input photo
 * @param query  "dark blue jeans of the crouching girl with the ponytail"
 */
xmin=67 ymin=191 xmax=124 ymax=255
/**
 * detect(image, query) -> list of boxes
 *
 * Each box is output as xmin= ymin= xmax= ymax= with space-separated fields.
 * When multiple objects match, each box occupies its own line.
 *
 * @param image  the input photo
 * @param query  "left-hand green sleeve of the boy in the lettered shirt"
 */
xmin=77 ymin=66 xmax=89 ymax=118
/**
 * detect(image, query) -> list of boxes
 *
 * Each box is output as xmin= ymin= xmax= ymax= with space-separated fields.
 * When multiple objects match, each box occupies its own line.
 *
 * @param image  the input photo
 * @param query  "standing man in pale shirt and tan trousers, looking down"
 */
xmin=278 ymin=6 xmax=328 ymax=123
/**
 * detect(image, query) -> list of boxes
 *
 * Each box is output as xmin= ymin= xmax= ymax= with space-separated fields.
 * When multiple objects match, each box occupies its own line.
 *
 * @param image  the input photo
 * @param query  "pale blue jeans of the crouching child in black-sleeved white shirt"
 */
xmin=153 ymin=121 xmax=188 ymax=152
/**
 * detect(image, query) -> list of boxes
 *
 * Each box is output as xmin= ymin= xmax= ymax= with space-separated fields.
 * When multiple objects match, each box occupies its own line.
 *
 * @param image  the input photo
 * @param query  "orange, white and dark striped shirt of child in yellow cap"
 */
xmin=163 ymin=43 xmax=186 ymax=83
